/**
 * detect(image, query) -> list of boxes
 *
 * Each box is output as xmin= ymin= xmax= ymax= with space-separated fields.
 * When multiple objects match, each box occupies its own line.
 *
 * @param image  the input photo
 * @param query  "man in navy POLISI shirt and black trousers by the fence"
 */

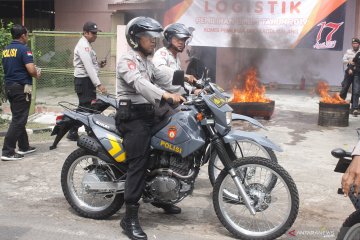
xmin=1 ymin=24 xmax=40 ymax=161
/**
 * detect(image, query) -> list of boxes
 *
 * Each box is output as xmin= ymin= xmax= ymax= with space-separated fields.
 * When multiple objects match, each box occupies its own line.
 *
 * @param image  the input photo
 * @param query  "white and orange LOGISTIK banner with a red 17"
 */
xmin=164 ymin=0 xmax=346 ymax=50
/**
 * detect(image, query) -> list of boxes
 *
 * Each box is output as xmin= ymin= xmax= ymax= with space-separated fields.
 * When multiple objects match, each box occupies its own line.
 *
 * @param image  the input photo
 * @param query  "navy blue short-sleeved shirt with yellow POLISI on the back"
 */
xmin=2 ymin=40 xmax=34 ymax=86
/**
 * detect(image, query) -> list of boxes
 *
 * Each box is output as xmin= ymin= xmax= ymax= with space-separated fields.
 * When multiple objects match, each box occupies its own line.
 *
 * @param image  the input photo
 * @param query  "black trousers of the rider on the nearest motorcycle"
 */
xmin=117 ymin=110 xmax=155 ymax=204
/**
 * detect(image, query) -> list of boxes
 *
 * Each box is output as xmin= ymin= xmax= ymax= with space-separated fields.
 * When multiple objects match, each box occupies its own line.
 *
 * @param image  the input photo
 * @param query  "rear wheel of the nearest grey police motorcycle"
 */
xmin=61 ymin=148 xmax=124 ymax=219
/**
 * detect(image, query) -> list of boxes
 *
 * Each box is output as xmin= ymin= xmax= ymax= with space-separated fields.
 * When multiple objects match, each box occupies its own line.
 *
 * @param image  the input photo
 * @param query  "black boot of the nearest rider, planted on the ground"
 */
xmin=120 ymin=204 xmax=147 ymax=240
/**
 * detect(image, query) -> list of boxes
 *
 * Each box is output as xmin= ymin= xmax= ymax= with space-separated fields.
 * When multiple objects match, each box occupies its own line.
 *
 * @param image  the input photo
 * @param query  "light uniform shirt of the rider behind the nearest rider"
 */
xmin=152 ymin=47 xmax=195 ymax=94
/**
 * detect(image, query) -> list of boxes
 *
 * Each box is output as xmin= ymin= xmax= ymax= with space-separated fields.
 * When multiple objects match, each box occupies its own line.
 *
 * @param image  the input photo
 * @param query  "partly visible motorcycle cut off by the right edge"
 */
xmin=331 ymin=128 xmax=360 ymax=240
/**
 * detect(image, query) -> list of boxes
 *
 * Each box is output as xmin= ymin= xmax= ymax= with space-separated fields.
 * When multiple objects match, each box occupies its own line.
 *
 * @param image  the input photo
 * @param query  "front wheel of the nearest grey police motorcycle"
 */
xmin=213 ymin=157 xmax=299 ymax=240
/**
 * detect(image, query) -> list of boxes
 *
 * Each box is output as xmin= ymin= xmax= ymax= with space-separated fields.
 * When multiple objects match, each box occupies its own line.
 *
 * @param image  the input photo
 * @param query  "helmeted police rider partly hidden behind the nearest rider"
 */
xmin=152 ymin=23 xmax=201 ymax=95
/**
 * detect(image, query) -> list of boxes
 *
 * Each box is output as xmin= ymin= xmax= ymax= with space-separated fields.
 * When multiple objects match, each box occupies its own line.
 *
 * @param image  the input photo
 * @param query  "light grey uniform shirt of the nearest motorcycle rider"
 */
xmin=117 ymin=50 xmax=165 ymax=106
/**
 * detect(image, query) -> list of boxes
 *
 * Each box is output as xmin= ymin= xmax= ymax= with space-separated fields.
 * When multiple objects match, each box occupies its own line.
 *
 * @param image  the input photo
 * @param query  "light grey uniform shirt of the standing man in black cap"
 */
xmin=74 ymin=36 xmax=101 ymax=87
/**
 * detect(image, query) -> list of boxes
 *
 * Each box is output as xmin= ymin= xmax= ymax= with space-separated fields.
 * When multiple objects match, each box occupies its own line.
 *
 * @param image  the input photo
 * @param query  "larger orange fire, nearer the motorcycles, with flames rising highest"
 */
xmin=231 ymin=68 xmax=271 ymax=102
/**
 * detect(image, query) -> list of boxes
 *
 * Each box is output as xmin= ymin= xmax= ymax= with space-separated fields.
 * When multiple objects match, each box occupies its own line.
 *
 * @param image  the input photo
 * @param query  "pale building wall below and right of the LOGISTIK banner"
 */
xmin=216 ymin=0 xmax=360 ymax=89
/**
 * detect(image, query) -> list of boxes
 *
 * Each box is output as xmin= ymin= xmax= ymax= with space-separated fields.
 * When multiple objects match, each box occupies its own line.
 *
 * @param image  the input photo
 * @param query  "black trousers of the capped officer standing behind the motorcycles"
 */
xmin=69 ymin=77 xmax=96 ymax=134
